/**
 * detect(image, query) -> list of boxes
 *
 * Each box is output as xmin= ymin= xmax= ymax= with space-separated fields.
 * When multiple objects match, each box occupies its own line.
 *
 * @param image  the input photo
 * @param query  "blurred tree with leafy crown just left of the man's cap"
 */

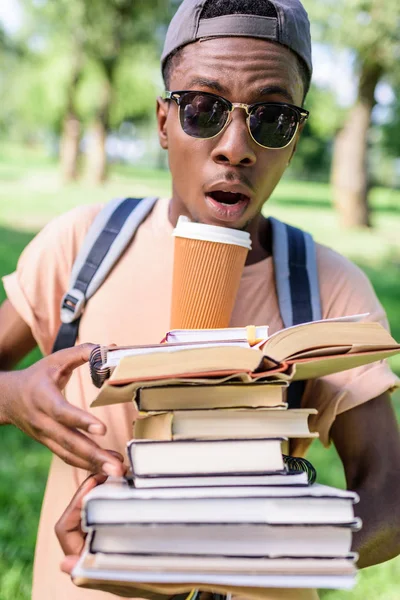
xmin=78 ymin=0 xmax=169 ymax=183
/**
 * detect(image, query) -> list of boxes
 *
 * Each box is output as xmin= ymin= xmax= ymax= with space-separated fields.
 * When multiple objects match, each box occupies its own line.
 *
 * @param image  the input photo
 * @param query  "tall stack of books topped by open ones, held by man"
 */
xmin=73 ymin=320 xmax=399 ymax=596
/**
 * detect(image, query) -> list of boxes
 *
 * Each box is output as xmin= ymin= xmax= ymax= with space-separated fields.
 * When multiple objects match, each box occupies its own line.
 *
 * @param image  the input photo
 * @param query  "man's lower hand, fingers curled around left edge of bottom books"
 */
xmin=54 ymin=474 xmax=107 ymax=556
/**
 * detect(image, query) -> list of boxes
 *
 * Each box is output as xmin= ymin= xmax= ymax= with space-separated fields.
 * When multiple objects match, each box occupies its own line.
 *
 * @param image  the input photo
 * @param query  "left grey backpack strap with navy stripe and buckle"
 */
xmin=52 ymin=198 xmax=157 ymax=352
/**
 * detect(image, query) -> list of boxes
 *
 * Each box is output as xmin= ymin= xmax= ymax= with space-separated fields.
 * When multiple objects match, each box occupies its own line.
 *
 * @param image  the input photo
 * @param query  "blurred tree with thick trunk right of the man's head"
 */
xmin=305 ymin=0 xmax=400 ymax=227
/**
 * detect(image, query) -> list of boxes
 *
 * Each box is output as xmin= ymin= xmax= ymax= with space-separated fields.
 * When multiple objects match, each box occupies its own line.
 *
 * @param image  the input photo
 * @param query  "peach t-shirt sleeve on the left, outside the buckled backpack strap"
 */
xmin=3 ymin=205 xmax=101 ymax=354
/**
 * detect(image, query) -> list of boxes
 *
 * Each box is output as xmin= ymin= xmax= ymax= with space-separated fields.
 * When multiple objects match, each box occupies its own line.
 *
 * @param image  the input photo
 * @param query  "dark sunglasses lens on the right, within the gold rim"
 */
xmin=250 ymin=104 xmax=299 ymax=148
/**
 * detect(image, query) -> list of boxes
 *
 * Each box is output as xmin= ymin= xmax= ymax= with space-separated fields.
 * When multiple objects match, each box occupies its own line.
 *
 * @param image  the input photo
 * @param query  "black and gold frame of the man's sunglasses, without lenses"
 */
xmin=164 ymin=90 xmax=310 ymax=150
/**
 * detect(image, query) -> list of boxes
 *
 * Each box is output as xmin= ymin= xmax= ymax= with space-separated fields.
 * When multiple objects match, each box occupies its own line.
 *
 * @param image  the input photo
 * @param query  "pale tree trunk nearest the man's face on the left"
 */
xmin=86 ymin=65 xmax=114 ymax=185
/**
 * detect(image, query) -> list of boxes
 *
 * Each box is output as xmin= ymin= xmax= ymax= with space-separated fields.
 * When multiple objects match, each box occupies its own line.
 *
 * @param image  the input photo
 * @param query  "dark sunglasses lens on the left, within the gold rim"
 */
xmin=179 ymin=92 xmax=229 ymax=138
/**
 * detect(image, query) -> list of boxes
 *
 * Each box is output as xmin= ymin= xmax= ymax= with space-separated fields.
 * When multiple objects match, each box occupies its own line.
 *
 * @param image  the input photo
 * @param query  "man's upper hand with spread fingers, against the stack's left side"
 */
xmin=0 ymin=344 xmax=124 ymax=476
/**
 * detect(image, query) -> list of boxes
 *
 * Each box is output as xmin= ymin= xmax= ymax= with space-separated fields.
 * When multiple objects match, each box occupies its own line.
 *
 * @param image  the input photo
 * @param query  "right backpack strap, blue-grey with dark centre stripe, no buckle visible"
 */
xmin=269 ymin=217 xmax=322 ymax=408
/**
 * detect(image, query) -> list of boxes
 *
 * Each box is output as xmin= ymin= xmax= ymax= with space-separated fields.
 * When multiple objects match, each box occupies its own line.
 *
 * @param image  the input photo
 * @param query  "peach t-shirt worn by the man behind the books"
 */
xmin=3 ymin=199 xmax=398 ymax=600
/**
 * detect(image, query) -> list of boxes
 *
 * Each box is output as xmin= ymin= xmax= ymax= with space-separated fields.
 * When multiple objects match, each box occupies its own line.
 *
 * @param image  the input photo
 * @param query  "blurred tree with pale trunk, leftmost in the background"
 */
xmin=15 ymin=0 xmax=85 ymax=182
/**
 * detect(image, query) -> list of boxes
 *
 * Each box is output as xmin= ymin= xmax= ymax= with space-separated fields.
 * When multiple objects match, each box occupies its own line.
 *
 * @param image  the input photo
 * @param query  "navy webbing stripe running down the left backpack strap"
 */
xmin=52 ymin=198 xmax=142 ymax=352
